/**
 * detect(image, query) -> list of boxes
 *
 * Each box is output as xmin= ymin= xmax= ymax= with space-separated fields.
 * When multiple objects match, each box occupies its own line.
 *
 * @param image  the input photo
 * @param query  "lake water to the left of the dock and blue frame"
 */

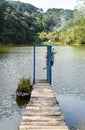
xmin=0 ymin=47 xmax=33 ymax=130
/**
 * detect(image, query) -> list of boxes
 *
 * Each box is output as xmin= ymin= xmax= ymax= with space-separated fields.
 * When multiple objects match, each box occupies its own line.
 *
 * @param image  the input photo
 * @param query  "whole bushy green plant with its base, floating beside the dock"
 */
xmin=16 ymin=78 xmax=32 ymax=97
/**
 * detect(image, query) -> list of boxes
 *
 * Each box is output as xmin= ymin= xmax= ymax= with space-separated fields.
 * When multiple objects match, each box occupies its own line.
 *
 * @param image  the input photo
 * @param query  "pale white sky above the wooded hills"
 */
xmin=20 ymin=0 xmax=76 ymax=11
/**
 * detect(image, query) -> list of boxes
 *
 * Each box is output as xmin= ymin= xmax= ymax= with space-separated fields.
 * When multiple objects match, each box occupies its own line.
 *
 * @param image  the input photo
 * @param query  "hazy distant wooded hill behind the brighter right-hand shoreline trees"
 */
xmin=44 ymin=8 xmax=73 ymax=31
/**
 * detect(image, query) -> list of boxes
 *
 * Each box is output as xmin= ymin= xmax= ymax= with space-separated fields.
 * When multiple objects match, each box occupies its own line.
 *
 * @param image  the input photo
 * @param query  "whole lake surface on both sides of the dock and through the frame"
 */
xmin=0 ymin=46 xmax=85 ymax=130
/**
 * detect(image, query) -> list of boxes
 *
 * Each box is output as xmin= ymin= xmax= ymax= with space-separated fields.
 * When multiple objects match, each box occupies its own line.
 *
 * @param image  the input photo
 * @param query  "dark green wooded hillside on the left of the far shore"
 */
xmin=0 ymin=1 xmax=41 ymax=44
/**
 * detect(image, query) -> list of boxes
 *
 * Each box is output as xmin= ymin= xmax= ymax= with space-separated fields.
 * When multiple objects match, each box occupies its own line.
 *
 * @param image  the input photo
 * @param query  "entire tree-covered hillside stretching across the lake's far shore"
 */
xmin=0 ymin=0 xmax=85 ymax=45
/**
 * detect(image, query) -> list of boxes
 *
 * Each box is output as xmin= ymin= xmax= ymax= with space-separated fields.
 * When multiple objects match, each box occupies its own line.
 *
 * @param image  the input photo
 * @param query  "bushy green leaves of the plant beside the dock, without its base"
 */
xmin=17 ymin=78 xmax=32 ymax=93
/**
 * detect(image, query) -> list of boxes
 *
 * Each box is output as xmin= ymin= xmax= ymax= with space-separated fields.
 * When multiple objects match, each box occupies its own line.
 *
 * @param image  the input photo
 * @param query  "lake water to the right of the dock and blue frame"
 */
xmin=53 ymin=46 xmax=85 ymax=130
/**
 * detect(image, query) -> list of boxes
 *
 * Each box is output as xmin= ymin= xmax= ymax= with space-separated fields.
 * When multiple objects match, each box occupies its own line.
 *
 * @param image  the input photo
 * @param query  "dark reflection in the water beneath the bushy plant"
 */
xmin=16 ymin=96 xmax=30 ymax=107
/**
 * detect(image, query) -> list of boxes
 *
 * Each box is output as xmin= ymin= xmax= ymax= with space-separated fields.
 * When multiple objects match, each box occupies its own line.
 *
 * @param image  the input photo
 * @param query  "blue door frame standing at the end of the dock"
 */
xmin=33 ymin=44 xmax=52 ymax=84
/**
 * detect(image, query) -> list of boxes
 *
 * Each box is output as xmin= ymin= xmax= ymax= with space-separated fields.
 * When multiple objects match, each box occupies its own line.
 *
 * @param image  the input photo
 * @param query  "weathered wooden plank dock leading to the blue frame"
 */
xmin=19 ymin=82 xmax=69 ymax=130
